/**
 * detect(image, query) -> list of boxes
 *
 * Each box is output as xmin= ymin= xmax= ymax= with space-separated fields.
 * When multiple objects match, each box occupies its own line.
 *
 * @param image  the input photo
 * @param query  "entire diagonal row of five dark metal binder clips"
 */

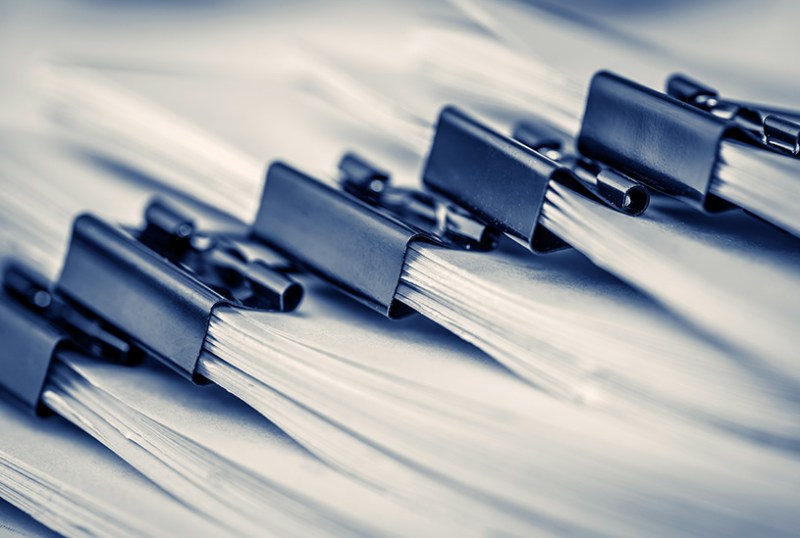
xmin=0 ymin=72 xmax=800 ymax=412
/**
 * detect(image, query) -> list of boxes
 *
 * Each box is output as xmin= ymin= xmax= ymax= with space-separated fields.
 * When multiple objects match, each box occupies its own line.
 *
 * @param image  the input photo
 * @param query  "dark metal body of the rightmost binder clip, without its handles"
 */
xmin=577 ymin=71 xmax=759 ymax=212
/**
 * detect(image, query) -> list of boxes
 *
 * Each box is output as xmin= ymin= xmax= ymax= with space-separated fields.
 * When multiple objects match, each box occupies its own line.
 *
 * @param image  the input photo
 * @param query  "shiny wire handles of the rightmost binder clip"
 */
xmin=667 ymin=75 xmax=800 ymax=156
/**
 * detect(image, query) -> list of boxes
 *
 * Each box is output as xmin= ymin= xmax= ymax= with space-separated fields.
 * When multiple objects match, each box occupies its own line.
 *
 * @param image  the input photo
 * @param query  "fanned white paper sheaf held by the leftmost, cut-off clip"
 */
xmin=44 ymin=355 xmax=469 ymax=536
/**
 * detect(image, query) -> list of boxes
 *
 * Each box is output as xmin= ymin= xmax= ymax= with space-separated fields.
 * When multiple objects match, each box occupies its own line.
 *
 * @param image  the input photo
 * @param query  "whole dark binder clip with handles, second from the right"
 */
xmin=422 ymin=107 xmax=649 ymax=253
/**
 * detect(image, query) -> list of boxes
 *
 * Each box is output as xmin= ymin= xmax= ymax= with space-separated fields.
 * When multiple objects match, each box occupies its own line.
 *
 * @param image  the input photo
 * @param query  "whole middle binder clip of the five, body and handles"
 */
xmin=252 ymin=154 xmax=498 ymax=318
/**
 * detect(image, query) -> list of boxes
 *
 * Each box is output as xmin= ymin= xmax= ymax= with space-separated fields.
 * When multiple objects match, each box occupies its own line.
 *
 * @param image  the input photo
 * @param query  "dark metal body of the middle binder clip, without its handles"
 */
xmin=252 ymin=162 xmax=432 ymax=318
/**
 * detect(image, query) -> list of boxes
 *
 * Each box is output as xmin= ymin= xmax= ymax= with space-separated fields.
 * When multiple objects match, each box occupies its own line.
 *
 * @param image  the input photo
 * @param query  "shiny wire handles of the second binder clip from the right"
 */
xmin=513 ymin=121 xmax=650 ymax=217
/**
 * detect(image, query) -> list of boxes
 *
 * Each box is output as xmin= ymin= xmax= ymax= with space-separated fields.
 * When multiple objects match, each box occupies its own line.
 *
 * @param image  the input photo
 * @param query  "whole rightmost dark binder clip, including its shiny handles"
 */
xmin=577 ymin=72 xmax=800 ymax=212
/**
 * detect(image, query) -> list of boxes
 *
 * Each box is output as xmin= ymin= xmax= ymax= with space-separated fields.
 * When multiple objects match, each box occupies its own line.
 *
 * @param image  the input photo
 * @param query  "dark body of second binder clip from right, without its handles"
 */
xmin=422 ymin=107 xmax=584 ymax=253
